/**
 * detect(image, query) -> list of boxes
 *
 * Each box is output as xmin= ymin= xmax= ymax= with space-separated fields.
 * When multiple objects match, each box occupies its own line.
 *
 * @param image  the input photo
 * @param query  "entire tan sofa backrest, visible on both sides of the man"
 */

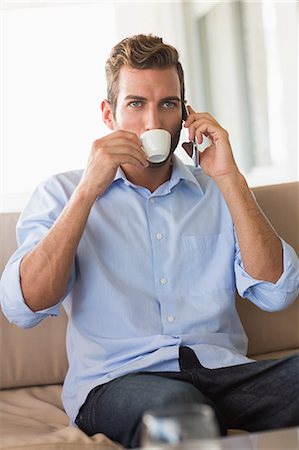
xmin=0 ymin=183 xmax=299 ymax=389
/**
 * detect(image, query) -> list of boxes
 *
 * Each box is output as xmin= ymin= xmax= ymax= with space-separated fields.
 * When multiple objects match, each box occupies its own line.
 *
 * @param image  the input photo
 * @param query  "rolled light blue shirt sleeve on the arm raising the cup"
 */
xmin=0 ymin=178 xmax=76 ymax=328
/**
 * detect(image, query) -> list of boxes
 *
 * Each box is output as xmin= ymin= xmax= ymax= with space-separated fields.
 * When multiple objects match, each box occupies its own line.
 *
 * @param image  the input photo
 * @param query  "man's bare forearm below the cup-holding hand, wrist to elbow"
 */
xmin=20 ymin=185 xmax=94 ymax=311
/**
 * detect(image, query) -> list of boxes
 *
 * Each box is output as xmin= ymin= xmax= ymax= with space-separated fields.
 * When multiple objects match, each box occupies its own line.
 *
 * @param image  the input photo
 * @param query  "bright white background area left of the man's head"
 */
xmin=1 ymin=3 xmax=116 ymax=210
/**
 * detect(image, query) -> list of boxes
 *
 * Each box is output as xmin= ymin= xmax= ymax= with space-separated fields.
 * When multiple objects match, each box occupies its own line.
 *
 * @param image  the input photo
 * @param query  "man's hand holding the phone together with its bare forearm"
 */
xmin=184 ymin=106 xmax=283 ymax=283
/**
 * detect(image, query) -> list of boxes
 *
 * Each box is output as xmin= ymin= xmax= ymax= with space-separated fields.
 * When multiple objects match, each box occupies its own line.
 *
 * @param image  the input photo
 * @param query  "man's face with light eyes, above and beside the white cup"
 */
xmin=113 ymin=66 xmax=182 ymax=156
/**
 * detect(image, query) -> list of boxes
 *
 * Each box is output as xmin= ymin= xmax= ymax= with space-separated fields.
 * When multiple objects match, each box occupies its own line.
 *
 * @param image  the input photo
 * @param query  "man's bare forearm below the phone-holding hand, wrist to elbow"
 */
xmin=215 ymin=171 xmax=283 ymax=283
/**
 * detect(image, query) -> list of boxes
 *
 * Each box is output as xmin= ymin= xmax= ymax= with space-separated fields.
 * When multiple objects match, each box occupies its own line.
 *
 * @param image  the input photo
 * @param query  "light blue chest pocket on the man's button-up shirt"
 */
xmin=184 ymin=234 xmax=235 ymax=295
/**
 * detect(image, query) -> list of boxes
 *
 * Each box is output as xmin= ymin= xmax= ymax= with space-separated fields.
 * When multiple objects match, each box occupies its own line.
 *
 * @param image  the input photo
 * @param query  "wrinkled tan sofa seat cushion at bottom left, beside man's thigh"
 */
xmin=0 ymin=385 xmax=121 ymax=450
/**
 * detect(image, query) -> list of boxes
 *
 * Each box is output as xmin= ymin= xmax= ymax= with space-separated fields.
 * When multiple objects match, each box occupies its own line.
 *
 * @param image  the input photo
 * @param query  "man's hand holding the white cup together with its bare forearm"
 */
xmin=20 ymin=131 xmax=148 ymax=311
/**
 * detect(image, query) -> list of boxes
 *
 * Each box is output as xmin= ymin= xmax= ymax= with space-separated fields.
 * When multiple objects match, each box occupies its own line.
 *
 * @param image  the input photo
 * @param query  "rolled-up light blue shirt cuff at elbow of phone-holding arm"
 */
xmin=235 ymin=234 xmax=299 ymax=311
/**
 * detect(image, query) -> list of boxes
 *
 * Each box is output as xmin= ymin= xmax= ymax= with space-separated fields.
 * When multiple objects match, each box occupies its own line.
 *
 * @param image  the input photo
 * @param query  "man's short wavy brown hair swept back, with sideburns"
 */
xmin=105 ymin=34 xmax=185 ymax=114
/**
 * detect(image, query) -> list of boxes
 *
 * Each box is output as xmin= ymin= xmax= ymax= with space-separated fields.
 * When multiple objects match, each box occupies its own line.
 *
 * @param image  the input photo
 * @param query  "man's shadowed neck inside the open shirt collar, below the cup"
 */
xmin=121 ymin=159 xmax=172 ymax=192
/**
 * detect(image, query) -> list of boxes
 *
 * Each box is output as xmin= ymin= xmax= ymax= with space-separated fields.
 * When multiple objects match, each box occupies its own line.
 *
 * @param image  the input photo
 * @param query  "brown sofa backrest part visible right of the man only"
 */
xmin=237 ymin=182 xmax=299 ymax=356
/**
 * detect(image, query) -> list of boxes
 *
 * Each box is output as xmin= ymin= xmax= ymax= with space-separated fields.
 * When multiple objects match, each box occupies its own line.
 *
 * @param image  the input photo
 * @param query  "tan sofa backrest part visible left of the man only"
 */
xmin=0 ymin=213 xmax=67 ymax=389
